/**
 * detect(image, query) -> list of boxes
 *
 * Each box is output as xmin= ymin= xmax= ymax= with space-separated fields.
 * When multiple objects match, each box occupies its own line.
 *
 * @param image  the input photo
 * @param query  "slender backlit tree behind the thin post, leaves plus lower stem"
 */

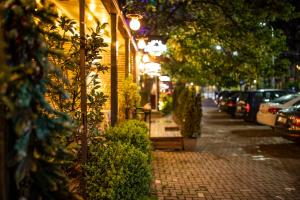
xmin=41 ymin=13 xmax=108 ymax=194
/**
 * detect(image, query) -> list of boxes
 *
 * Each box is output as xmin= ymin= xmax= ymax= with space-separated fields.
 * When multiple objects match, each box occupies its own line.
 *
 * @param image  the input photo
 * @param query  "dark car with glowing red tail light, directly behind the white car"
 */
xmin=235 ymin=89 xmax=289 ymax=122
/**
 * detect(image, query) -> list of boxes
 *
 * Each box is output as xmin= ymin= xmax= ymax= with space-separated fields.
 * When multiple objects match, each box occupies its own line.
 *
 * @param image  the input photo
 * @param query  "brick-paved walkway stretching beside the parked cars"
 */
xmin=153 ymin=100 xmax=300 ymax=200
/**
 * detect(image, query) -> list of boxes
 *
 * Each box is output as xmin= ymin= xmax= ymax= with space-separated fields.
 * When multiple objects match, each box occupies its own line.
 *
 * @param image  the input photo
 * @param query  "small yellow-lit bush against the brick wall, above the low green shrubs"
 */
xmin=121 ymin=76 xmax=141 ymax=119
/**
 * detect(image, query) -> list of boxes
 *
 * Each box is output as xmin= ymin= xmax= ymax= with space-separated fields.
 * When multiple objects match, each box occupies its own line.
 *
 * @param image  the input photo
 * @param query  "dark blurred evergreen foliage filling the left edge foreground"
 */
xmin=0 ymin=0 xmax=79 ymax=200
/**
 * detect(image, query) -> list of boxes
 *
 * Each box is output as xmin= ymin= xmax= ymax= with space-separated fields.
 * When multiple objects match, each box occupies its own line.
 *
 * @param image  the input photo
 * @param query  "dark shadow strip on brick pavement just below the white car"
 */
xmin=231 ymin=129 xmax=278 ymax=137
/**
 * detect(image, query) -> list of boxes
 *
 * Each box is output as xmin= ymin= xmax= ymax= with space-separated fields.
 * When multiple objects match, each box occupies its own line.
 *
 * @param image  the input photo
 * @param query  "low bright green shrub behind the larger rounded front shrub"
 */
xmin=104 ymin=120 xmax=151 ymax=161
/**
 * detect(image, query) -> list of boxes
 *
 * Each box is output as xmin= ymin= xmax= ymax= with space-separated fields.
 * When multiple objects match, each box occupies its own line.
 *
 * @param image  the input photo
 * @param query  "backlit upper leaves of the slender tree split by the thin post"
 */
xmin=44 ymin=16 xmax=108 ymax=134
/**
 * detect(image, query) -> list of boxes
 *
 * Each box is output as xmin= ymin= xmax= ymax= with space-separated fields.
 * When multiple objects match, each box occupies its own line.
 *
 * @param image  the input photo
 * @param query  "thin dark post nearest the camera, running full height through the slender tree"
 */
xmin=79 ymin=0 xmax=87 ymax=198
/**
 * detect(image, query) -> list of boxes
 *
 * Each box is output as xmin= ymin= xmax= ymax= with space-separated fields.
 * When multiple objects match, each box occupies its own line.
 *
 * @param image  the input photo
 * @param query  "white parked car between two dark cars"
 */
xmin=256 ymin=94 xmax=300 ymax=127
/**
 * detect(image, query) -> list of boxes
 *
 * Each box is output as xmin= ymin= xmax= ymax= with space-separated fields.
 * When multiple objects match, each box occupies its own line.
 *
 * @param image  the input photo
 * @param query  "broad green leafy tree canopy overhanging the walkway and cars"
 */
xmin=128 ymin=0 xmax=297 ymax=86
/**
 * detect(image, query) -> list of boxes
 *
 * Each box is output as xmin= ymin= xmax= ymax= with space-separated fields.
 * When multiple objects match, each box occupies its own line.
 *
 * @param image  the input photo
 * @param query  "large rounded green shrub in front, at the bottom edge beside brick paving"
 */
xmin=85 ymin=141 xmax=151 ymax=200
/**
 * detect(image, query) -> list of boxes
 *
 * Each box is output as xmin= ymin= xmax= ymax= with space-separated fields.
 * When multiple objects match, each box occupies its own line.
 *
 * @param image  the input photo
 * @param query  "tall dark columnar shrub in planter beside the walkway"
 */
xmin=174 ymin=87 xmax=202 ymax=137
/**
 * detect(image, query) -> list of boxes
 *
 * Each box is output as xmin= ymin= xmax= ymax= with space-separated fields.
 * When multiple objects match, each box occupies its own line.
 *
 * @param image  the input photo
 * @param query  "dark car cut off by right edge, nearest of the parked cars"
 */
xmin=275 ymin=105 xmax=300 ymax=139
